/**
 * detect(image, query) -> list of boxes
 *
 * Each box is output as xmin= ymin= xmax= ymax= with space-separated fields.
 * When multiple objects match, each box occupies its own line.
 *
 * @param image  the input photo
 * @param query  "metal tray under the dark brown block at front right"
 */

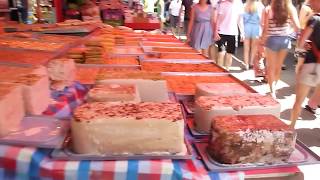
xmin=194 ymin=140 xmax=320 ymax=172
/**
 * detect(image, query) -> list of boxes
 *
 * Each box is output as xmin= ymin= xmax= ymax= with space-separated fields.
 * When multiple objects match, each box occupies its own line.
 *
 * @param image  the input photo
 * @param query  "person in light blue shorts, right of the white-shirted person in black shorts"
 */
xmin=243 ymin=0 xmax=264 ymax=70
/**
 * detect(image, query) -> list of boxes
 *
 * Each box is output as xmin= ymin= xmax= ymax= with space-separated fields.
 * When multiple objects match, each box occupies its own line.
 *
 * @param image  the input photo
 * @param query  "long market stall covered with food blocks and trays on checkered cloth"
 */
xmin=0 ymin=21 xmax=320 ymax=179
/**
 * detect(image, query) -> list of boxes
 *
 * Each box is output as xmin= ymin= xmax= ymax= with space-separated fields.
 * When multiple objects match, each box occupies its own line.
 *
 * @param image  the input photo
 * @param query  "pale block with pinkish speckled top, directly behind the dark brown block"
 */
xmin=194 ymin=93 xmax=280 ymax=133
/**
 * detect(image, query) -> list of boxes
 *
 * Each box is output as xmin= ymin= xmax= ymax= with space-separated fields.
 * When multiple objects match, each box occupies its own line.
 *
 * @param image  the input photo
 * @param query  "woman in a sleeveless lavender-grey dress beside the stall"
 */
xmin=187 ymin=0 xmax=216 ymax=57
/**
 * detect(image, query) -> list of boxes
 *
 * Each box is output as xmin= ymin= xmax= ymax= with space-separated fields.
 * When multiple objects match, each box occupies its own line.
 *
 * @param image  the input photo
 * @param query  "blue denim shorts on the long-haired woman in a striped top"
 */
xmin=266 ymin=36 xmax=291 ymax=51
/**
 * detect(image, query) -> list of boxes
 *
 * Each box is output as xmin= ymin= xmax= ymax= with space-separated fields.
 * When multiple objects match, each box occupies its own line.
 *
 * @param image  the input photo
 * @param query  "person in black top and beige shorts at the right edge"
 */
xmin=291 ymin=0 xmax=320 ymax=127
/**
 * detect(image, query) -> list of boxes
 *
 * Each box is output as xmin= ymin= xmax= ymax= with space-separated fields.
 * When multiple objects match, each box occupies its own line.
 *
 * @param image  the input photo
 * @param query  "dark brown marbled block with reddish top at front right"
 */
xmin=208 ymin=115 xmax=296 ymax=164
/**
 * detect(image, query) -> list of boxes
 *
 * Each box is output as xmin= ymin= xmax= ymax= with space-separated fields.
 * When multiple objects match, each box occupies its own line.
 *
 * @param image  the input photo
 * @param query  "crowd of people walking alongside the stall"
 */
xmin=146 ymin=0 xmax=320 ymax=126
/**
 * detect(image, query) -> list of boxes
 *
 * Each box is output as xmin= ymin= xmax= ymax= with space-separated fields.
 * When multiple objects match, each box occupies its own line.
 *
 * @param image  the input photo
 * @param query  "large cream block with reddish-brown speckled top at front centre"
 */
xmin=71 ymin=102 xmax=186 ymax=154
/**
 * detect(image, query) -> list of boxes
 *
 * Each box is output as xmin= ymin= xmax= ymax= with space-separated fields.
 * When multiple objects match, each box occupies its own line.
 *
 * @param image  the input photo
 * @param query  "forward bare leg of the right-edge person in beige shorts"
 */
xmin=290 ymin=83 xmax=311 ymax=127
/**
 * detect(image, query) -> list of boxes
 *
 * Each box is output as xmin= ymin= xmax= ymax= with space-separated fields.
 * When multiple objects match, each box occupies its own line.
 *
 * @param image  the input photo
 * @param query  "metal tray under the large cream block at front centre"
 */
xmin=51 ymin=136 xmax=192 ymax=161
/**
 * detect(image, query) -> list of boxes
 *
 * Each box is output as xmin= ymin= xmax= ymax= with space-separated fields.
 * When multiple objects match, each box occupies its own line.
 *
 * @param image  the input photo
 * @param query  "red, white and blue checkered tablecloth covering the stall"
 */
xmin=0 ymin=83 xmax=299 ymax=180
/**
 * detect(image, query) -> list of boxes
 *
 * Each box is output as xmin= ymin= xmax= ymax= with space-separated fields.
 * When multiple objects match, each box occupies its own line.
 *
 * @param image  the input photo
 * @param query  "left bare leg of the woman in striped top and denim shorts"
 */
xmin=266 ymin=48 xmax=277 ymax=97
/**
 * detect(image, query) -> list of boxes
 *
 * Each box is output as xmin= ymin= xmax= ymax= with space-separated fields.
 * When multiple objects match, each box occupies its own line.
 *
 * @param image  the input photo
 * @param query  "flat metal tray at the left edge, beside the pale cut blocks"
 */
xmin=0 ymin=116 xmax=70 ymax=148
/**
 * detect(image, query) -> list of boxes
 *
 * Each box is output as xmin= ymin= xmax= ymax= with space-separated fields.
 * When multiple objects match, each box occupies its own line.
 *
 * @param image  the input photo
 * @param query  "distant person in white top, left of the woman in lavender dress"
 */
xmin=169 ymin=0 xmax=181 ymax=33
